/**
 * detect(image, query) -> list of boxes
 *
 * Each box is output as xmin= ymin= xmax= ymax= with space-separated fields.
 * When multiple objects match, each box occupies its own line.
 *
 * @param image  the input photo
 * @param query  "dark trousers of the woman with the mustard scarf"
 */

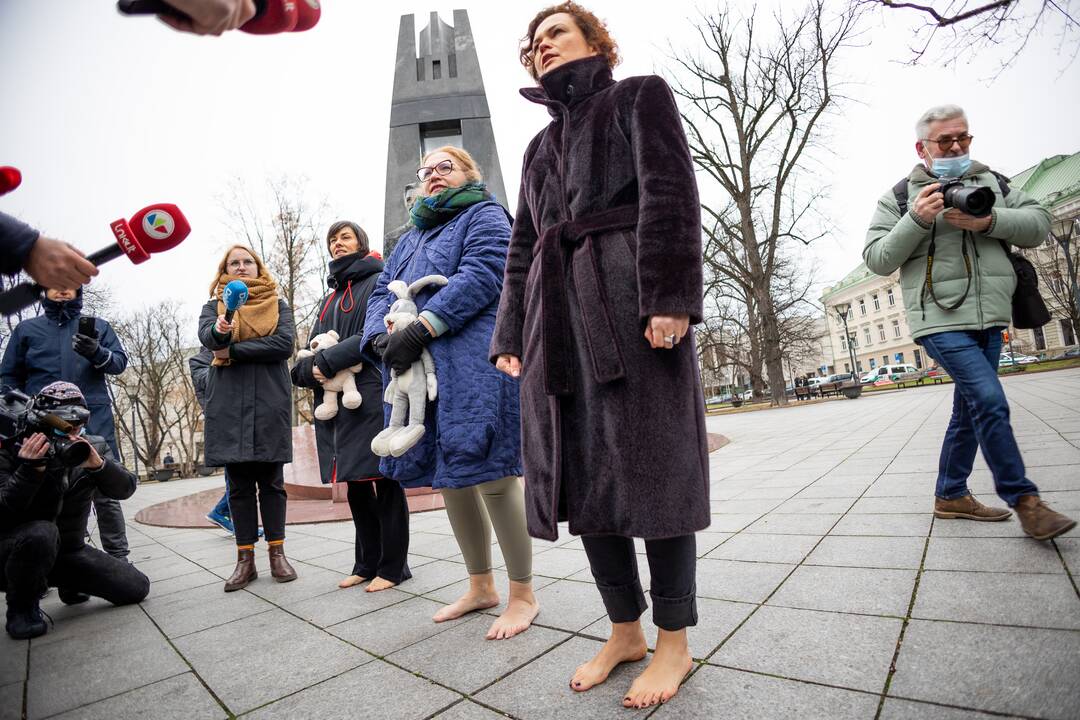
xmin=225 ymin=462 xmax=285 ymax=545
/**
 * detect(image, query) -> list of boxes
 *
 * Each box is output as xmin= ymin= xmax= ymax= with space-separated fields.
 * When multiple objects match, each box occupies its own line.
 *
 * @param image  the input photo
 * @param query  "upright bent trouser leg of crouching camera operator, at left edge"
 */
xmin=0 ymin=520 xmax=60 ymax=608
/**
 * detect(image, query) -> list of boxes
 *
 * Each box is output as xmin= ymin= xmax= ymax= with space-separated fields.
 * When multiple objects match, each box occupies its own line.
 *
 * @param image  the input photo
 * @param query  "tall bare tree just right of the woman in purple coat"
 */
xmin=672 ymin=0 xmax=861 ymax=405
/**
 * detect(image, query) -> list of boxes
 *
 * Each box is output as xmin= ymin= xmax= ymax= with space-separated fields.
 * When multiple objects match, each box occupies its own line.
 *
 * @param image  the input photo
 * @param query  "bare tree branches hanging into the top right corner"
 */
xmin=860 ymin=0 xmax=1080 ymax=73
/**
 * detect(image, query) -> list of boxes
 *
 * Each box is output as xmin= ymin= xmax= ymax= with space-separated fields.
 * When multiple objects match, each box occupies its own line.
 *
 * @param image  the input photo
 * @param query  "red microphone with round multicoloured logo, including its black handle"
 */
xmin=0 ymin=203 xmax=191 ymax=315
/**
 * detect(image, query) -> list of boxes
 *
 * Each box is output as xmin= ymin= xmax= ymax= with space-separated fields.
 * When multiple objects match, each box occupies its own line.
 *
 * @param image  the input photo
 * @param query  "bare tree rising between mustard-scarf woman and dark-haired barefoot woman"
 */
xmin=219 ymin=177 xmax=329 ymax=424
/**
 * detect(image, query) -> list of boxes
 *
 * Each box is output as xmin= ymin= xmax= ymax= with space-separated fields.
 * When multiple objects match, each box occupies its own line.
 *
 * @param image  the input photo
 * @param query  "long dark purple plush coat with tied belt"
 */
xmin=490 ymin=57 xmax=710 ymax=540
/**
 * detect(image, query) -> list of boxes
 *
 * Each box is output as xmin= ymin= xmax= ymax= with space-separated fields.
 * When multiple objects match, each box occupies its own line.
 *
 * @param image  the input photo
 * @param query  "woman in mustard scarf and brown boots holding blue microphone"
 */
xmin=199 ymin=245 xmax=296 ymax=593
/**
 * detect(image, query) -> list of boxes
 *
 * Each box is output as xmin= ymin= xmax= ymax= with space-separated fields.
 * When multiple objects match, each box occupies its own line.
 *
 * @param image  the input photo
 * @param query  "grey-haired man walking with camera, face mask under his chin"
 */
xmin=863 ymin=105 xmax=1076 ymax=540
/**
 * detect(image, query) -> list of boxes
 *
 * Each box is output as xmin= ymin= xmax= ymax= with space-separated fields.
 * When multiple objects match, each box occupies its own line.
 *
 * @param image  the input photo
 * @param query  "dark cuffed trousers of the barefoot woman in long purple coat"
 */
xmin=581 ymin=534 xmax=698 ymax=630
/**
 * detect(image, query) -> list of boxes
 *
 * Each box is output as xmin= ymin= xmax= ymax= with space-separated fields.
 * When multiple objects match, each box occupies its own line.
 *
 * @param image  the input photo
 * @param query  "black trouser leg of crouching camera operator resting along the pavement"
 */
xmin=49 ymin=545 xmax=150 ymax=604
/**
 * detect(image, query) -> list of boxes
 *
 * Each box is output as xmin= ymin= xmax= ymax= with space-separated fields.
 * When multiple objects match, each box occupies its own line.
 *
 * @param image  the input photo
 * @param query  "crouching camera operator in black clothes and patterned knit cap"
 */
xmin=0 ymin=382 xmax=150 ymax=640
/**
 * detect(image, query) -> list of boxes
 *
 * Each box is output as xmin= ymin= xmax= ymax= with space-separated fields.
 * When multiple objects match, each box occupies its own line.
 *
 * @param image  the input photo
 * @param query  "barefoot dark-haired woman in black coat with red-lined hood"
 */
xmin=293 ymin=220 xmax=413 ymax=593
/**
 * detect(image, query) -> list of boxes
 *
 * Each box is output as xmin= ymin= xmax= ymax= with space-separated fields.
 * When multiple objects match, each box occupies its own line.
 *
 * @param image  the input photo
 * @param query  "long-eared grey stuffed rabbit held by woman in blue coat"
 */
xmin=372 ymin=275 xmax=449 ymax=458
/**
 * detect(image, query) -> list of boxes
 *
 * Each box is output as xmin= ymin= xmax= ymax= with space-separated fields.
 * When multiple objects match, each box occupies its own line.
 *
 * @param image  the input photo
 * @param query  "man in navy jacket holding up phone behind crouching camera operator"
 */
xmin=0 ymin=288 xmax=129 ymax=559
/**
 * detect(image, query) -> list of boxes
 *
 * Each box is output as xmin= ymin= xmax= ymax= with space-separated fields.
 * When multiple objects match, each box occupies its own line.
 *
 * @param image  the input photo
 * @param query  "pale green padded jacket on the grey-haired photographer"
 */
xmin=863 ymin=162 xmax=1050 ymax=339
